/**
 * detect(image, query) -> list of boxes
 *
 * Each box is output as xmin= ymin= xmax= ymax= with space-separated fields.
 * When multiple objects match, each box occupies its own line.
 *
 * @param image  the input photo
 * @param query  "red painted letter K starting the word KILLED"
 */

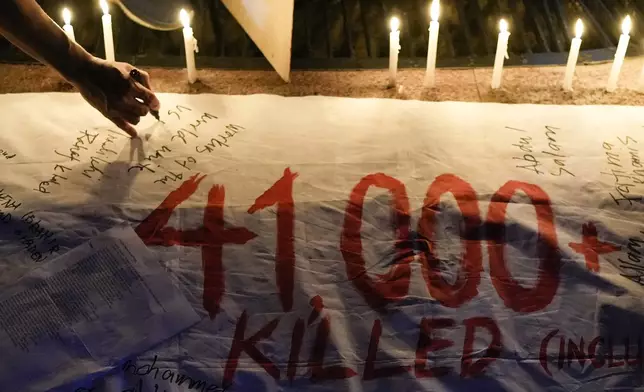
xmin=223 ymin=311 xmax=280 ymax=385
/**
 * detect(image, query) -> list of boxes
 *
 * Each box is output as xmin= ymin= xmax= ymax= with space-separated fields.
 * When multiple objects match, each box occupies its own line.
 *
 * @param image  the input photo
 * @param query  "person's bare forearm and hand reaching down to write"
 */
xmin=0 ymin=0 xmax=159 ymax=136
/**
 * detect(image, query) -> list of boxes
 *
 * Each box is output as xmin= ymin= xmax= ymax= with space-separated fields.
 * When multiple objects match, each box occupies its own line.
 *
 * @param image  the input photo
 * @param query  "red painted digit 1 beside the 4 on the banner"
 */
xmin=248 ymin=168 xmax=298 ymax=312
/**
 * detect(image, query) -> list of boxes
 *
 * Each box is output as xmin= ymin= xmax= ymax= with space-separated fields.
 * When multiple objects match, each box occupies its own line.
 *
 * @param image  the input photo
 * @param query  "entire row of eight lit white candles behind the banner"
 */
xmin=63 ymin=0 xmax=644 ymax=92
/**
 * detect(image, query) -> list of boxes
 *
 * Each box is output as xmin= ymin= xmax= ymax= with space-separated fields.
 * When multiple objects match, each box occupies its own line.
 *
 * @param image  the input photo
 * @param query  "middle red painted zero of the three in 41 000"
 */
xmin=418 ymin=174 xmax=483 ymax=308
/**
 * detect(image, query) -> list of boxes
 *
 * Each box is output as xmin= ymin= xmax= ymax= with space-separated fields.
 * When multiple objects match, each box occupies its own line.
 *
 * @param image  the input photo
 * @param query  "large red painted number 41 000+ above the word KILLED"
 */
xmin=136 ymin=169 xmax=604 ymax=318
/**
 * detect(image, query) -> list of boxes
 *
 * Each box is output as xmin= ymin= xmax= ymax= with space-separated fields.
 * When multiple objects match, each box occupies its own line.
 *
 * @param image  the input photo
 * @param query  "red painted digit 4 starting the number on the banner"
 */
xmin=136 ymin=174 xmax=257 ymax=318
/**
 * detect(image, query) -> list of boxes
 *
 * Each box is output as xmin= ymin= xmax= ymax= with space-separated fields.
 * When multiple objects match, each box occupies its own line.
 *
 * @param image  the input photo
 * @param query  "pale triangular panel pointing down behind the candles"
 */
xmin=222 ymin=0 xmax=295 ymax=82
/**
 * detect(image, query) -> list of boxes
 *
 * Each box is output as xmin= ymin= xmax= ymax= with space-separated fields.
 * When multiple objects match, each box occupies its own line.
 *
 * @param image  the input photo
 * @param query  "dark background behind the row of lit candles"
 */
xmin=0 ymin=0 xmax=644 ymax=68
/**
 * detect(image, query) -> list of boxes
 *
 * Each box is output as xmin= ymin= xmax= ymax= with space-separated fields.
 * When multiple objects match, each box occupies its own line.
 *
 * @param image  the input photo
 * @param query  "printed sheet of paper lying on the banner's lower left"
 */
xmin=0 ymin=227 xmax=199 ymax=392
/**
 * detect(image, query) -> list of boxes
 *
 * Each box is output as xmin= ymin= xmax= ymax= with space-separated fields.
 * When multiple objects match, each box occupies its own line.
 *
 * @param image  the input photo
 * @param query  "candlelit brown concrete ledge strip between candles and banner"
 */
xmin=0 ymin=58 xmax=644 ymax=105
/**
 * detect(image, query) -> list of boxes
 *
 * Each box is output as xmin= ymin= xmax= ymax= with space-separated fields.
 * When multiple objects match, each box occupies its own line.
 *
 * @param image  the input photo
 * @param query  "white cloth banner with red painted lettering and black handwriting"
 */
xmin=0 ymin=94 xmax=644 ymax=392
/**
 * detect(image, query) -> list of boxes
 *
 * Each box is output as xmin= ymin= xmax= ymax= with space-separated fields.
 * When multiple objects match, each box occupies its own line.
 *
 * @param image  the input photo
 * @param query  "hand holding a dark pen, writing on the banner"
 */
xmin=71 ymin=57 xmax=160 ymax=137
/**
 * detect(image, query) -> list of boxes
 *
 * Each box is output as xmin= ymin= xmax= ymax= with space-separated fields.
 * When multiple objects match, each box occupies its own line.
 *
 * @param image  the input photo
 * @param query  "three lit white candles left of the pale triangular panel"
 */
xmin=63 ymin=0 xmax=199 ymax=83
